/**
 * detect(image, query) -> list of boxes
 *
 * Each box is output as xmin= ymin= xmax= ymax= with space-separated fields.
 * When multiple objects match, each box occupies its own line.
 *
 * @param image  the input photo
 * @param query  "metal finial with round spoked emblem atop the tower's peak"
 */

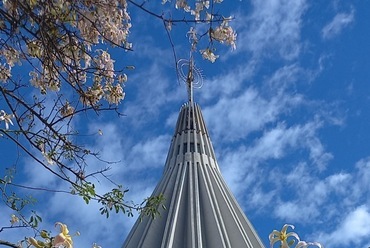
xmin=177 ymin=54 xmax=203 ymax=102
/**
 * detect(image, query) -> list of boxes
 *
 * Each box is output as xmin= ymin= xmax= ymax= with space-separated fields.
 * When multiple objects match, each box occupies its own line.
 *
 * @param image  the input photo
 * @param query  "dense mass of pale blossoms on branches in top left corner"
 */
xmin=0 ymin=0 xmax=132 ymax=106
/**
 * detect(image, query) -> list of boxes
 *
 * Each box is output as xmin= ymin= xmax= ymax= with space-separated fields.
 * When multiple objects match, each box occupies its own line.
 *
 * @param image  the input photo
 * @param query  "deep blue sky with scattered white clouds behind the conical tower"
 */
xmin=0 ymin=0 xmax=370 ymax=248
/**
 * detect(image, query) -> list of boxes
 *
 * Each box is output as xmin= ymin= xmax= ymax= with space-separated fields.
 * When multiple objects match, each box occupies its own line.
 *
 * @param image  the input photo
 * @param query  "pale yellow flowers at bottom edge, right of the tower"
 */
xmin=269 ymin=224 xmax=324 ymax=248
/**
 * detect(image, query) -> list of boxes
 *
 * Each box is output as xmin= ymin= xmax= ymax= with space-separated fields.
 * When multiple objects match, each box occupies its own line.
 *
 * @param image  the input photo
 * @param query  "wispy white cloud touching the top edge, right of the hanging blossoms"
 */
xmin=238 ymin=0 xmax=307 ymax=60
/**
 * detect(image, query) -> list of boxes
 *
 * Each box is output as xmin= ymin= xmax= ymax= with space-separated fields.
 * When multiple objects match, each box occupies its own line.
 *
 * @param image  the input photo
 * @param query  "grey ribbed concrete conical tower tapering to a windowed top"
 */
xmin=123 ymin=101 xmax=264 ymax=248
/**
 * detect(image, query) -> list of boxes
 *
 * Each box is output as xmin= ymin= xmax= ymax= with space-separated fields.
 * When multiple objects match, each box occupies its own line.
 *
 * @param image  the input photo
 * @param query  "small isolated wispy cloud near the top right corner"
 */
xmin=321 ymin=9 xmax=355 ymax=39
